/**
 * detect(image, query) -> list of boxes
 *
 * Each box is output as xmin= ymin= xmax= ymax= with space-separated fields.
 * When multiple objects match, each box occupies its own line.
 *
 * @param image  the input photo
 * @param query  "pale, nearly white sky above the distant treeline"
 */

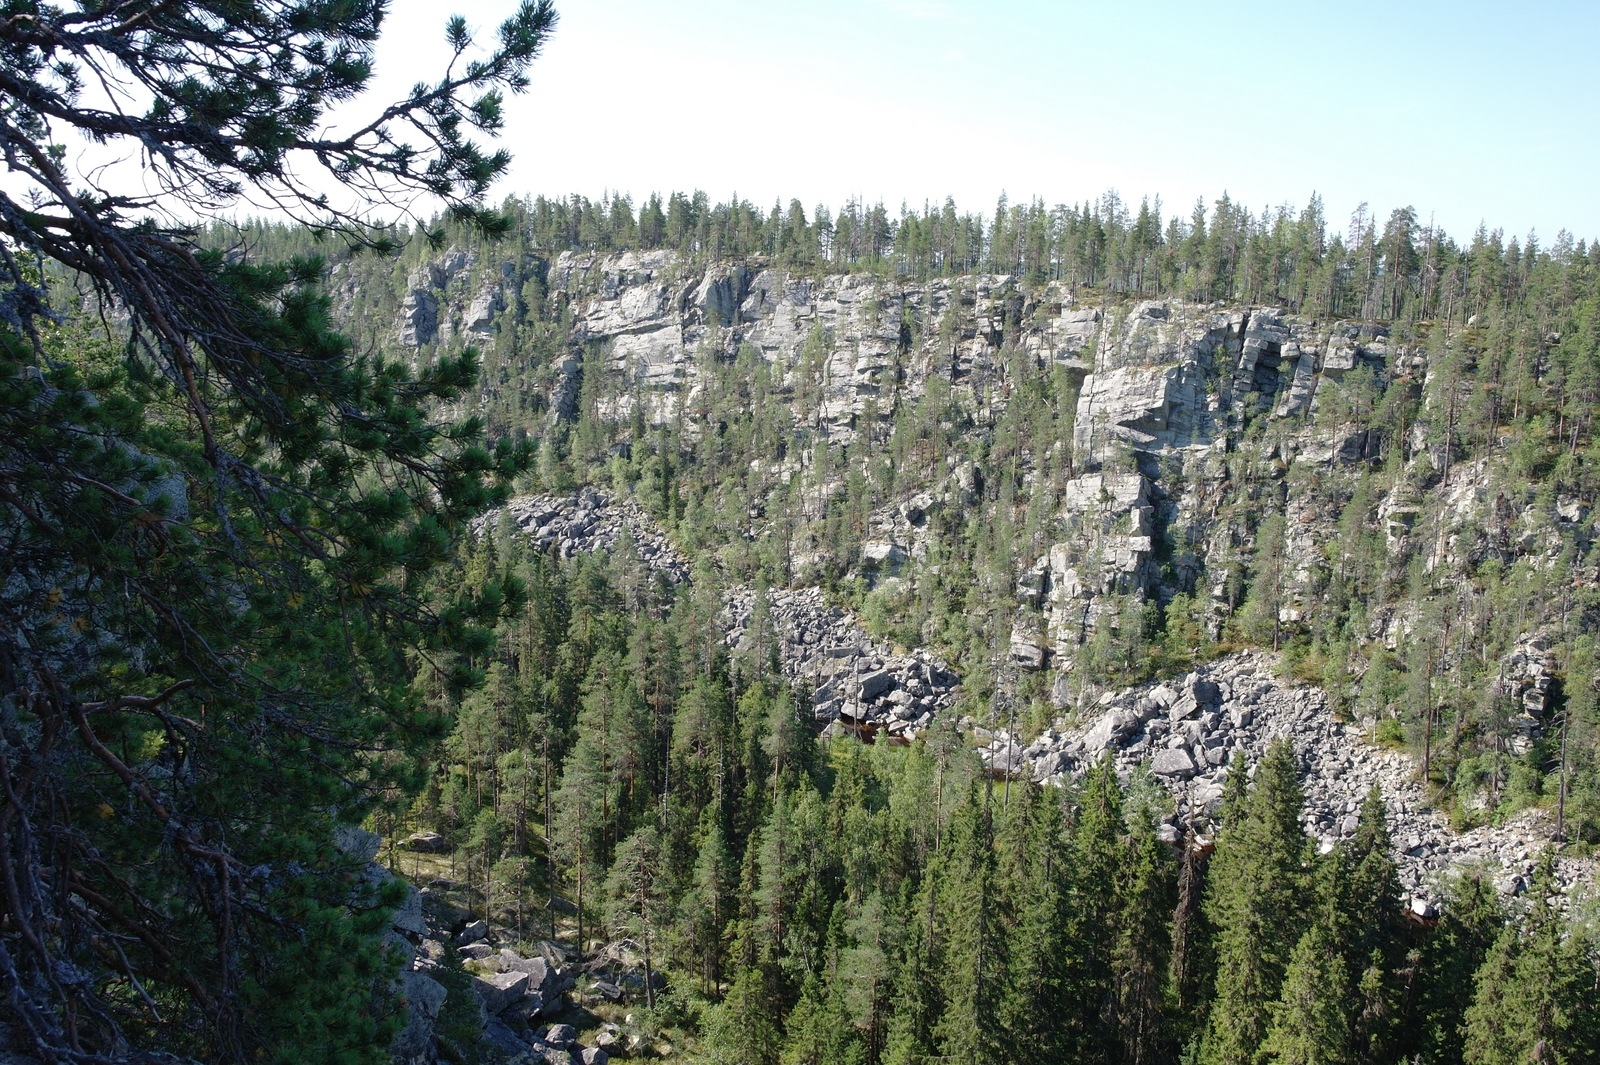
xmin=25 ymin=0 xmax=1600 ymax=243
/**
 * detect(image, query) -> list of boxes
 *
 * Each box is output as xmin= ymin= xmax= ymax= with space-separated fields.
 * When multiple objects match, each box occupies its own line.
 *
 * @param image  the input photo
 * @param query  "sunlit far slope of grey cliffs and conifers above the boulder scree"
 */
xmin=288 ymin=186 xmax=1600 ymax=824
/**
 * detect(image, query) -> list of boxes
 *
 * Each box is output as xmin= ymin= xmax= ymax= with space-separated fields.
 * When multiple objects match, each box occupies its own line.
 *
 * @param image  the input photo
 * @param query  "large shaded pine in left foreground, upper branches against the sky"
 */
xmin=0 ymin=0 xmax=555 ymax=1062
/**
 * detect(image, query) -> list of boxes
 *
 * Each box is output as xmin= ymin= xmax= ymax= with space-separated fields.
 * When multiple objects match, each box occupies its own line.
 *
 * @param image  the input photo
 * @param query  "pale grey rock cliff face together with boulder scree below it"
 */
xmin=406 ymin=244 xmax=1600 ymax=895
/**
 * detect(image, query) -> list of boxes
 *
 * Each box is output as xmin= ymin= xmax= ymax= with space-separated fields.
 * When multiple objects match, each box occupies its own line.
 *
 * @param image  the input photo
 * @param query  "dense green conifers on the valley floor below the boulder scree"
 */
xmin=403 ymin=552 xmax=1600 ymax=1065
